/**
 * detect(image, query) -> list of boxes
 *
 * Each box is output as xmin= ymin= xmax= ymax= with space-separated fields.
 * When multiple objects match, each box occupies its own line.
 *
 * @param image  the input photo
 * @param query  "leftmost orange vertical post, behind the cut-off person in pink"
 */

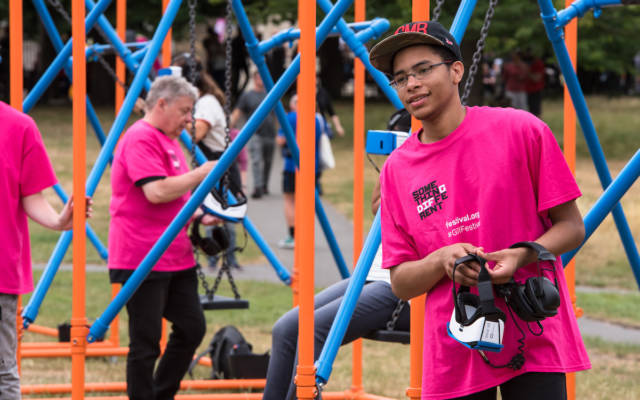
xmin=9 ymin=0 xmax=23 ymax=371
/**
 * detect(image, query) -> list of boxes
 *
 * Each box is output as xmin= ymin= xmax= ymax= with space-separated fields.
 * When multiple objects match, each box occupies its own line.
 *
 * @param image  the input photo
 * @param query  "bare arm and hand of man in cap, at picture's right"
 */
xmin=479 ymin=200 xmax=585 ymax=283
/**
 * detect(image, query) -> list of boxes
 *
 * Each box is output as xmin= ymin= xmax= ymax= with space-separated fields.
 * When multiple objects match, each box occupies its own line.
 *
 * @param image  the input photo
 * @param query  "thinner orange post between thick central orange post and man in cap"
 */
xmin=351 ymin=0 xmax=366 ymax=393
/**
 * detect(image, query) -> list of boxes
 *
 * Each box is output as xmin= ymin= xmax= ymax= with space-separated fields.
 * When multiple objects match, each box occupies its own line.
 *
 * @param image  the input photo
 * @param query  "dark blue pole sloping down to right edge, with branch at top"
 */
xmin=538 ymin=0 xmax=640 ymax=287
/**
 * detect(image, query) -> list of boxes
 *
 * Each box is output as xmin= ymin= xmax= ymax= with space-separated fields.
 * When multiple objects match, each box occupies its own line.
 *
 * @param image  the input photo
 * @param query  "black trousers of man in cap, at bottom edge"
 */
xmin=456 ymin=372 xmax=567 ymax=400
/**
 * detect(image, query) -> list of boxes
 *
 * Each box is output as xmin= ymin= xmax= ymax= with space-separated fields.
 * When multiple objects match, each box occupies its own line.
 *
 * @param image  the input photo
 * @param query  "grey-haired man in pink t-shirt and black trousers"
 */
xmin=109 ymin=76 xmax=219 ymax=399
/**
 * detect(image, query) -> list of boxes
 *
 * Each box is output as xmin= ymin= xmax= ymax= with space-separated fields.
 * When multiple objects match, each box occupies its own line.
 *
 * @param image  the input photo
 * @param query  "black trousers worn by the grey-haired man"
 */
xmin=127 ymin=268 xmax=206 ymax=400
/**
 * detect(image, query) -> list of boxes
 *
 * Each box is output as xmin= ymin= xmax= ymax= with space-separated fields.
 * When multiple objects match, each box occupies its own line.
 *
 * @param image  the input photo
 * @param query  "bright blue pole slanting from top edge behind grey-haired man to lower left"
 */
xmin=23 ymin=0 xmax=182 ymax=328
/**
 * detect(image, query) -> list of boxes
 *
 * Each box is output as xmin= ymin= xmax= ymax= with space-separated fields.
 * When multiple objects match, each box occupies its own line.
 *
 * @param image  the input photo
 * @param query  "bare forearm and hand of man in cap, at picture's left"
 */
xmin=391 ymin=243 xmax=482 ymax=300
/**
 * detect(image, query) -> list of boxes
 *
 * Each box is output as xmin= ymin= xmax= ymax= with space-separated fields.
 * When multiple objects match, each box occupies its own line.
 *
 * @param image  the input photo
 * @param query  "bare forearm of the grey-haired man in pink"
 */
xmin=142 ymin=161 xmax=216 ymax=204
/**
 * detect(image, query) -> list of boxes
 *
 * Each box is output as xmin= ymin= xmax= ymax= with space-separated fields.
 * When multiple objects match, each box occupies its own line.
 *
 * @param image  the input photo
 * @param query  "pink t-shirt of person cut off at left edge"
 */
xmin=0 ymin=102 xmax=57 ymax=294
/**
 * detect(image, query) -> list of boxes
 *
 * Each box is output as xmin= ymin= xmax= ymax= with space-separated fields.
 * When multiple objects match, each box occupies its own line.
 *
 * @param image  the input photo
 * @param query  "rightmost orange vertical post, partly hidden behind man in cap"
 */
xmin=563 ymin=0 xmax=582 ymax=400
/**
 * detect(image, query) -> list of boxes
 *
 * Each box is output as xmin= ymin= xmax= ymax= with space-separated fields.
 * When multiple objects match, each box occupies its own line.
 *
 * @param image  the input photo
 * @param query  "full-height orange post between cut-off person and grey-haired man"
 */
xmin=71 ymin=0 xmax=88 ymax=400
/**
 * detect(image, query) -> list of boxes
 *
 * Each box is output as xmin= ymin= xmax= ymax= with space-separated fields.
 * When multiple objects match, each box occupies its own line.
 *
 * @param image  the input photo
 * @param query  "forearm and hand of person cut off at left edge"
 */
xmin=22 ymin=192 xmax=93 ymax=231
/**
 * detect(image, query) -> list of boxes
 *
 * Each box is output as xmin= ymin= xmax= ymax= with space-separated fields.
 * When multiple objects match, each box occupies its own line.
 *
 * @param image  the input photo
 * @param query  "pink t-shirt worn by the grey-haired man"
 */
xmin=109 ymin=120 xmax=195 ymax=271
